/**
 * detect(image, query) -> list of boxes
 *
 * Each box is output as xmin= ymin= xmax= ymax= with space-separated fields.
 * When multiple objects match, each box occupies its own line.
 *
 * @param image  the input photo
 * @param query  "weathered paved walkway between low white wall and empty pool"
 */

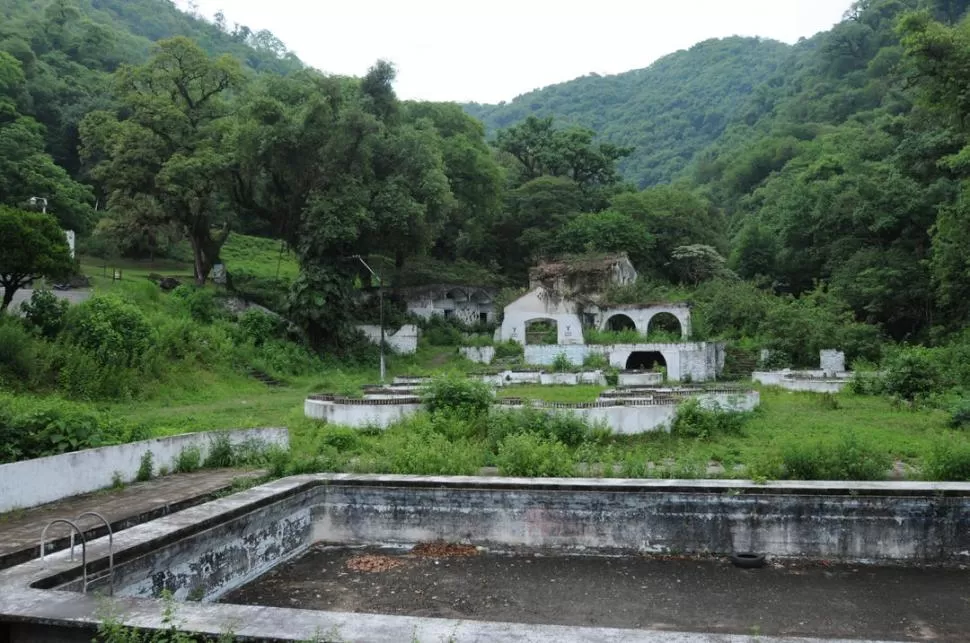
xmin=0 ymin=469 xmax=264 ymax=569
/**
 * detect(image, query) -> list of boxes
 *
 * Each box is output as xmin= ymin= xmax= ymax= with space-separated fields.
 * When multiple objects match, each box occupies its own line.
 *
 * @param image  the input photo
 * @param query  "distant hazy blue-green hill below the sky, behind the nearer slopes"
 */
xmin=463 ymin=37 xmax=794 ymax=187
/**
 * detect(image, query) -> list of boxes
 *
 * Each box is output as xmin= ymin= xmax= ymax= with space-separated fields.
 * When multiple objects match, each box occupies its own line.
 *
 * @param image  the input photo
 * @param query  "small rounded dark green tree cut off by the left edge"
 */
xmin=0 ymin=206 xmax=74 ymax=313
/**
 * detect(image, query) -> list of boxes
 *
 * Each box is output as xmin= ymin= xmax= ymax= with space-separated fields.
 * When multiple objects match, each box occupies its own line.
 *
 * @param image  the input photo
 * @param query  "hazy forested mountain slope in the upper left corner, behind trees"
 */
xmin=0 ymin=0 xmax=303 ymax=176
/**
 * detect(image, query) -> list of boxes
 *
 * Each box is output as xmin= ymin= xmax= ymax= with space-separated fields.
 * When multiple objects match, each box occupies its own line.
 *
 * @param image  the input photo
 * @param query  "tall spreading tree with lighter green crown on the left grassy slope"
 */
xmin=81 ymin=38 xmax=242 ymax=285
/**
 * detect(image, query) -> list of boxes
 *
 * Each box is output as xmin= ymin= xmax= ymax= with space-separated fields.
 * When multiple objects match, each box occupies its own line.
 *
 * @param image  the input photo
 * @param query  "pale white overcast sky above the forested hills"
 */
xmin=176 ymin=0 xmax=852 ymax=103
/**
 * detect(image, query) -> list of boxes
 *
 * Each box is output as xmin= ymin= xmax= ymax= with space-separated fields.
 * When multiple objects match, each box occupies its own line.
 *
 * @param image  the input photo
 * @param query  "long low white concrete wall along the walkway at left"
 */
xmin=0 ymin=429 xmax=290 ymax=512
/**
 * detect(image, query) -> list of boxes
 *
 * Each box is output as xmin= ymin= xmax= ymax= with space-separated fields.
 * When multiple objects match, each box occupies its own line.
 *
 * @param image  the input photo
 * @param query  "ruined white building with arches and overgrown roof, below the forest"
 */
xmin=499 ymin=254 xmax=724 ymax=382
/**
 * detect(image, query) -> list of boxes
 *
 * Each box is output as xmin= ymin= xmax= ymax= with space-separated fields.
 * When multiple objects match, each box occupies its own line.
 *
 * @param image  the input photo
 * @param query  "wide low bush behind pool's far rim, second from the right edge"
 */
xmin=781 ymin=433 xmax=892 ymax=480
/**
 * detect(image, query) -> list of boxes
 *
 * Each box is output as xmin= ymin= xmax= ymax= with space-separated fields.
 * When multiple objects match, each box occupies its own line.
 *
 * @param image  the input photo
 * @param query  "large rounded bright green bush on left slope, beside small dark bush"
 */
xmin=66 ymin=295 xmax=153 ymax=366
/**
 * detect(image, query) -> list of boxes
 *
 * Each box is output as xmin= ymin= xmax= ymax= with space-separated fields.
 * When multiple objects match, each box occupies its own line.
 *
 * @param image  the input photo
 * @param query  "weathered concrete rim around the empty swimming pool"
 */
xmin=0 ymin=474 xmax=970 ymax=641
